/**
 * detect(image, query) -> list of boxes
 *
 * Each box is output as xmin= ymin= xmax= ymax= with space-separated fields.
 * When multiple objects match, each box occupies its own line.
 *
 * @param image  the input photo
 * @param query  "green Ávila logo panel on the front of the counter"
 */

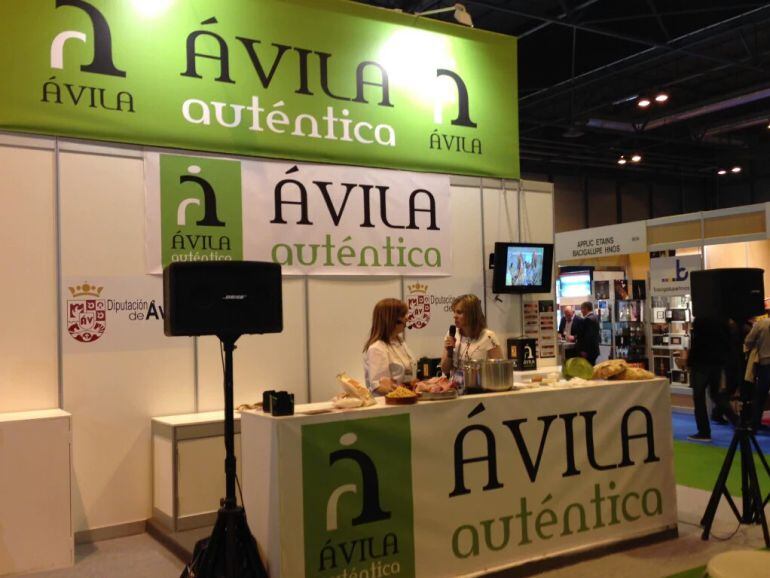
xmin=302 ymin=413 xmax=415 ymax=578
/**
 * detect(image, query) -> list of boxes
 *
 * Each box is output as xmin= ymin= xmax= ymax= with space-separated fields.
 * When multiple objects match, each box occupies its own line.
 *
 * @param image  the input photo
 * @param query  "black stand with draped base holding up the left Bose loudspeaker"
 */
xmin=181 ymin=335 xmax=267 ymax=578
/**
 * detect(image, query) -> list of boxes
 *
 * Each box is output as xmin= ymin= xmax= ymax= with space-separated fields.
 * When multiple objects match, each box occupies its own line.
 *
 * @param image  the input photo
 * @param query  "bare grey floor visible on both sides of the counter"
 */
xmin=18 ymin=486 xmax=770 ymax=578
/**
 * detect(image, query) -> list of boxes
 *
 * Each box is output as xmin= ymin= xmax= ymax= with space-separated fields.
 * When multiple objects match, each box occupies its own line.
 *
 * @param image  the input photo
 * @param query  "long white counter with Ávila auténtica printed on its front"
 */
xmin=241 ymin=379 xmax=677 ymax=578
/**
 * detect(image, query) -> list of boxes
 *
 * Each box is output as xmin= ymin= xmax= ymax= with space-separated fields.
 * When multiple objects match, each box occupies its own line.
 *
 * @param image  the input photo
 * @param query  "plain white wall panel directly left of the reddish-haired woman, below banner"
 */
xmin=308 ymin=277 xmax=401 ymax=402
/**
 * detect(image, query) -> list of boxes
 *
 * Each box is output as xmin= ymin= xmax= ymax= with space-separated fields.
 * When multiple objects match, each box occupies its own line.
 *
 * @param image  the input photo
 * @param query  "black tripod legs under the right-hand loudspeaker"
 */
xmin=700 ymin=402 xmax=770 ymax=548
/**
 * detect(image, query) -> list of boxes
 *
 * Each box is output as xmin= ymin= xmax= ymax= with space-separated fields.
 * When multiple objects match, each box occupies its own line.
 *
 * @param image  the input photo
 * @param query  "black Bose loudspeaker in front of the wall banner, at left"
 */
xmin=163 ymin=261 xmax=283 ymax=337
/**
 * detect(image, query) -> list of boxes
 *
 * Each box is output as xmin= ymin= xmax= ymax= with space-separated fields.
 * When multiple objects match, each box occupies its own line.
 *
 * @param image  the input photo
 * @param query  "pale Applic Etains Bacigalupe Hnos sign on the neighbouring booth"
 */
xmin=554 ymin=221 xmax=647 ymax=263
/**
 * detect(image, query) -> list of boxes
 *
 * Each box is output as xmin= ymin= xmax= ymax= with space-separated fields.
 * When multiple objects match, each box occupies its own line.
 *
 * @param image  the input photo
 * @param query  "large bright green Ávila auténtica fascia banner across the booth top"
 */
xmin=0 ymin=0 xmax=519 ymax=178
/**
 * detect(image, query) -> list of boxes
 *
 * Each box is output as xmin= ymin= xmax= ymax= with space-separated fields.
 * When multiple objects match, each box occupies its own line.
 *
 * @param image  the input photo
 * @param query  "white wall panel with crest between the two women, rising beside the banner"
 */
xmin=404 ymin=187 xmax=485 ymax=358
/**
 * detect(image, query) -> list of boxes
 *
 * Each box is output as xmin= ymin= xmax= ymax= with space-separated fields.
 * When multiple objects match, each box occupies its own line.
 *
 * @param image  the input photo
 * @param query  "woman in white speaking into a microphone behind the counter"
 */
xmin=441 ymin=295 xmax=503 ymax=375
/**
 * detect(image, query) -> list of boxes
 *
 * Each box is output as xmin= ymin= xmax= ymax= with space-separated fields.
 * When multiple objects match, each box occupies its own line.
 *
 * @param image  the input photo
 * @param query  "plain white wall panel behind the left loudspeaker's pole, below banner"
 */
xmin=198 ymin=277 xmax=309 ymax=411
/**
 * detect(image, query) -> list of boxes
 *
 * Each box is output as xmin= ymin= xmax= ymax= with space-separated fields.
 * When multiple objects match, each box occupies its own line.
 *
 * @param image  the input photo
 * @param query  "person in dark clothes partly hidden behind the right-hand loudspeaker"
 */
xmin=687 ymin=316 xmax=736 ymax=442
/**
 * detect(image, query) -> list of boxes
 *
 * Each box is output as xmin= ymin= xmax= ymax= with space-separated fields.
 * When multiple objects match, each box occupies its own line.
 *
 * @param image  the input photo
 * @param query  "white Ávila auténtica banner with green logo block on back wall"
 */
xmin=145 ymin=153 xmax=452 ymax=276
